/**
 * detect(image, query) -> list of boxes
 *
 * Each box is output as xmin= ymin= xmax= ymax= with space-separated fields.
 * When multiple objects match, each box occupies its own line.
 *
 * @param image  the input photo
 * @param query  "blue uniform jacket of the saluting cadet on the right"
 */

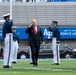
xmin=49 ymin=26 xmax=60 ymax=42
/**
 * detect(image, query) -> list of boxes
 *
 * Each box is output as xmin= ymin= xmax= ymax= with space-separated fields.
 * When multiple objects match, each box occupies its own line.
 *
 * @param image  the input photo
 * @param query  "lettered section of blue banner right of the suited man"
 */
xmin=43 ymin=28 xmax=76 ymax=39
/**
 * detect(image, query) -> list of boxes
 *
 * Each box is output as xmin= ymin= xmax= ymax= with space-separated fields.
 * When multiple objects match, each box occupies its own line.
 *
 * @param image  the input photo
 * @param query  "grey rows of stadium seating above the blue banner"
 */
xmin=0 ymin=2 xmax=76 ymax=26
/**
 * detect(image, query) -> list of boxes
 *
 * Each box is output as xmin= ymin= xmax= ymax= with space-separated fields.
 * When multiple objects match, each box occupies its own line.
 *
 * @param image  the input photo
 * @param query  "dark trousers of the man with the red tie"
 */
xmin=30 ymin=46 xmax=40 ymax=66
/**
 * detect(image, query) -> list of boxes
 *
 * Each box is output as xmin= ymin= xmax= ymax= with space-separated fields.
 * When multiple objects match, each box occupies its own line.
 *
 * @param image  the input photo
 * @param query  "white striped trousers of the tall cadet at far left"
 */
xmin=4 ymin=33 xmax=13 ymax=66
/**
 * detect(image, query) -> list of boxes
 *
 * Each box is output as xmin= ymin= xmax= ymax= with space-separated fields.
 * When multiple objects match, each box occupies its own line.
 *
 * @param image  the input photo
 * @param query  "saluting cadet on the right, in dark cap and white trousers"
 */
xmin=49 ymin=21 xmax=60 ymax=65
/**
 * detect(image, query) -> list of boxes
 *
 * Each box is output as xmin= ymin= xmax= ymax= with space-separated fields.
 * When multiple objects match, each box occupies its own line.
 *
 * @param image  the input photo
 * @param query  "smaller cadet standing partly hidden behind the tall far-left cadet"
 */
xmin=12 ymin=26 xmax=19 ymax=63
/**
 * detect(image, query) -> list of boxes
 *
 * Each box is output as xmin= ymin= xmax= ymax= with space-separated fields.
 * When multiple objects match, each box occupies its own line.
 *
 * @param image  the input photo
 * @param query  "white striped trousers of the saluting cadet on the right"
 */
xmin=52 ymin=38 xmax=60 ymax=64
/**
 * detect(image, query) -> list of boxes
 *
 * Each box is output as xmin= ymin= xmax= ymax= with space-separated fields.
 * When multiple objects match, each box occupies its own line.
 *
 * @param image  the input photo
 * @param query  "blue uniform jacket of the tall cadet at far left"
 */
xmin=2 ymin=21 xmax=13 ymax=38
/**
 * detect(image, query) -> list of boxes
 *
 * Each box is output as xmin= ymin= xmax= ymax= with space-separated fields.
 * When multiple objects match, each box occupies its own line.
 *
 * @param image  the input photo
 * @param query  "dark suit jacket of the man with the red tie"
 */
xmin=25 ymin=26 xmax=44 ymax=46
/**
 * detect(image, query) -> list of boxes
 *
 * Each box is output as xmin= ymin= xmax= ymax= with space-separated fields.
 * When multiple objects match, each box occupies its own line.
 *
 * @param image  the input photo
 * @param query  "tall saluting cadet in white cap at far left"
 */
xmin=2 ymin=14 xmax=13 ymax=68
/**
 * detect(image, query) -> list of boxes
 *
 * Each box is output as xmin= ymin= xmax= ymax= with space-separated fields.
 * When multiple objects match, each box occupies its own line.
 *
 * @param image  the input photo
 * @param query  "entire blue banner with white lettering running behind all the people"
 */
xmin=0 ymin=28 xmax=76 ymax=40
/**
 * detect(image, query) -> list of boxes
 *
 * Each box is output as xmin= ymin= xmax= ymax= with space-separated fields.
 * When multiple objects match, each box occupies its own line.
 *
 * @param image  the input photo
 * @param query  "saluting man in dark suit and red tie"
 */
xmin=25 ymin=20 xmax=44 ymax=66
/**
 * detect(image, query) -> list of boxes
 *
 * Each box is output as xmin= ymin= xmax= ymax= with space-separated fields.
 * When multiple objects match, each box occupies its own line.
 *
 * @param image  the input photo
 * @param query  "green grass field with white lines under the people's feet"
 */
xmin=0 ymin=59 xmax=76 ymax=75
